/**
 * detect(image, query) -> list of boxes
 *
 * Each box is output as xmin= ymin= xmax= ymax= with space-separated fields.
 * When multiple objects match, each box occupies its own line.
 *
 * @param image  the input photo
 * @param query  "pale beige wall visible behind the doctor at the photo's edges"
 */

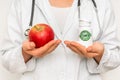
xmin=0 ymin=0 xmax=120 ymax=80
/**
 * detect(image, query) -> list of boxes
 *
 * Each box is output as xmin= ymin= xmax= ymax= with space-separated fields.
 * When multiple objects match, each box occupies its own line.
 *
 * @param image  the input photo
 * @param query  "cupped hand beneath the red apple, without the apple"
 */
xmin=22 ymin=40 xmax=61 ymax=62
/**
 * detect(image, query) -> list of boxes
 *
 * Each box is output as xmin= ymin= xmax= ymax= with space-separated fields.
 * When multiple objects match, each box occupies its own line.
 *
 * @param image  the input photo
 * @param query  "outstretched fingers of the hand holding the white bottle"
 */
xmin=64 ymin=41 xmax=99 ymax=58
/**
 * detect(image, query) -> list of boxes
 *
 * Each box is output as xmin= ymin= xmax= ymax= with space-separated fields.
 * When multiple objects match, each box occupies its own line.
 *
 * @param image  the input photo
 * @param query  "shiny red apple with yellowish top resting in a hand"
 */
xmin=28 ymin=24 xmax=54 ymax=48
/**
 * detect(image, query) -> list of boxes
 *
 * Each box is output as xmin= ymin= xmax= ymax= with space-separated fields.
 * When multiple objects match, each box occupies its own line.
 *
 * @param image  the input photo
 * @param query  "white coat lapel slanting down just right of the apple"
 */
xmin=36 ymin=0 xmax=62 ymax=39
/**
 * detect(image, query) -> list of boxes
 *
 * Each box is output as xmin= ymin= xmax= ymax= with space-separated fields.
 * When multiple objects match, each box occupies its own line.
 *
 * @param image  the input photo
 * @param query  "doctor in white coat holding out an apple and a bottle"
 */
xmin=0 ymin=0 xmax=120 ymax=80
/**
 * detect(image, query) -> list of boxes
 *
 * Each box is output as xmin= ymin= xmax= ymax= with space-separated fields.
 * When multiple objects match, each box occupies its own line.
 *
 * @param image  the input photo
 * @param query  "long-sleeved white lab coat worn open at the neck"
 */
xmin=0 ymin=0 xmax=120 ymax=80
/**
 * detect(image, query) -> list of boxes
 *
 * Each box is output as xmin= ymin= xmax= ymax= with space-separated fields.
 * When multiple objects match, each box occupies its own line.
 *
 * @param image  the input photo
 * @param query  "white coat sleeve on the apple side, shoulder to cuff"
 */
xmin=0 ymin=0 xmax=36 ymax=73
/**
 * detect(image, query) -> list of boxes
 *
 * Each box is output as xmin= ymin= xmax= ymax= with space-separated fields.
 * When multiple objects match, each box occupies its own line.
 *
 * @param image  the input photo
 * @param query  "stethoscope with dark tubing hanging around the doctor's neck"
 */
xmin=24 ymin=0 xmax=103 ymax=40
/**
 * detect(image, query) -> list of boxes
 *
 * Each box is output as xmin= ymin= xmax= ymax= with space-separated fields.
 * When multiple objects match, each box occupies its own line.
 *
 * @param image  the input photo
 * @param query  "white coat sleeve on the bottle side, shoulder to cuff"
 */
xmin=87 ymin=0 xmax=120 ymax=74
